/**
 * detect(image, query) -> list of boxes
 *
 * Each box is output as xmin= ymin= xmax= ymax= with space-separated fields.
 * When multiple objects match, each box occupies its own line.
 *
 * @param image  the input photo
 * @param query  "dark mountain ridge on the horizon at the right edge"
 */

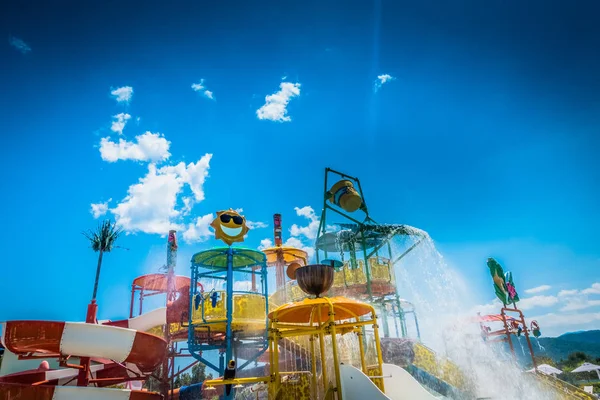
xmin=532 ymin=330 xmax=600 ymax=361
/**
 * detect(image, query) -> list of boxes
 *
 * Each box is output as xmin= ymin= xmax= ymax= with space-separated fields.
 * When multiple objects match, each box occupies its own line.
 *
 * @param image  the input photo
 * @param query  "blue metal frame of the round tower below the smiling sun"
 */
xmin=188 ymin=247 xmax=269 ymax=398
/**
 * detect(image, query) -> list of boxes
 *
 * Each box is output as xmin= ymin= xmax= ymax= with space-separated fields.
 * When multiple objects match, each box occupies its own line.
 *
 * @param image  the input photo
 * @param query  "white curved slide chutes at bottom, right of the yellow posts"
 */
xmin=340 ymin=364 xmax=438 ymax=400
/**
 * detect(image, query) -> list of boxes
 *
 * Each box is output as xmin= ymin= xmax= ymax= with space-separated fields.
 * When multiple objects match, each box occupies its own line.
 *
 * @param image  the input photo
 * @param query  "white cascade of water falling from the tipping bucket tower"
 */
xmin=394 ymin=232 xmax=554 ymax=400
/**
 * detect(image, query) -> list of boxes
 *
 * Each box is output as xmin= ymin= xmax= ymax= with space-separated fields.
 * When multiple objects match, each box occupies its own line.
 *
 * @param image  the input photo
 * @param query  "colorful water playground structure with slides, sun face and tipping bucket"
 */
xmin=0 ymin=168 xmax=585 ymax=400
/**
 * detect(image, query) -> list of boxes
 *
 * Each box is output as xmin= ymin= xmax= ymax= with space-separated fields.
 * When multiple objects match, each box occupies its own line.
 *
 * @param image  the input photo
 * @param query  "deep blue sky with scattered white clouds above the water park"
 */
xmin=0 ymin=1 xmax=600 ymax=344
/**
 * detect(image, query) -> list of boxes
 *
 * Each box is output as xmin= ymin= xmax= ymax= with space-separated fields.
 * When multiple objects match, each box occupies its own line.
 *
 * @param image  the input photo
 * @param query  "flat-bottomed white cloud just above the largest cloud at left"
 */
xmin=100 ymin=132 xmax=171 ymax=162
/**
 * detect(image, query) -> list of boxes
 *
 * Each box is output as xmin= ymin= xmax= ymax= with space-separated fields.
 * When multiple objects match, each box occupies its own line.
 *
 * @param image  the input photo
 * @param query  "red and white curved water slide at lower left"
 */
xmin=0 ymin=318 xmax=167 ymax=400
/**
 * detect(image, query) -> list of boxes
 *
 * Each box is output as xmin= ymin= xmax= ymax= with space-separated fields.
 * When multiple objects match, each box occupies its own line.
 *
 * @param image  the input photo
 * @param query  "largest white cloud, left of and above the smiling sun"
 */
xmin=110 ymin=154 xmax=212 ymax=234
